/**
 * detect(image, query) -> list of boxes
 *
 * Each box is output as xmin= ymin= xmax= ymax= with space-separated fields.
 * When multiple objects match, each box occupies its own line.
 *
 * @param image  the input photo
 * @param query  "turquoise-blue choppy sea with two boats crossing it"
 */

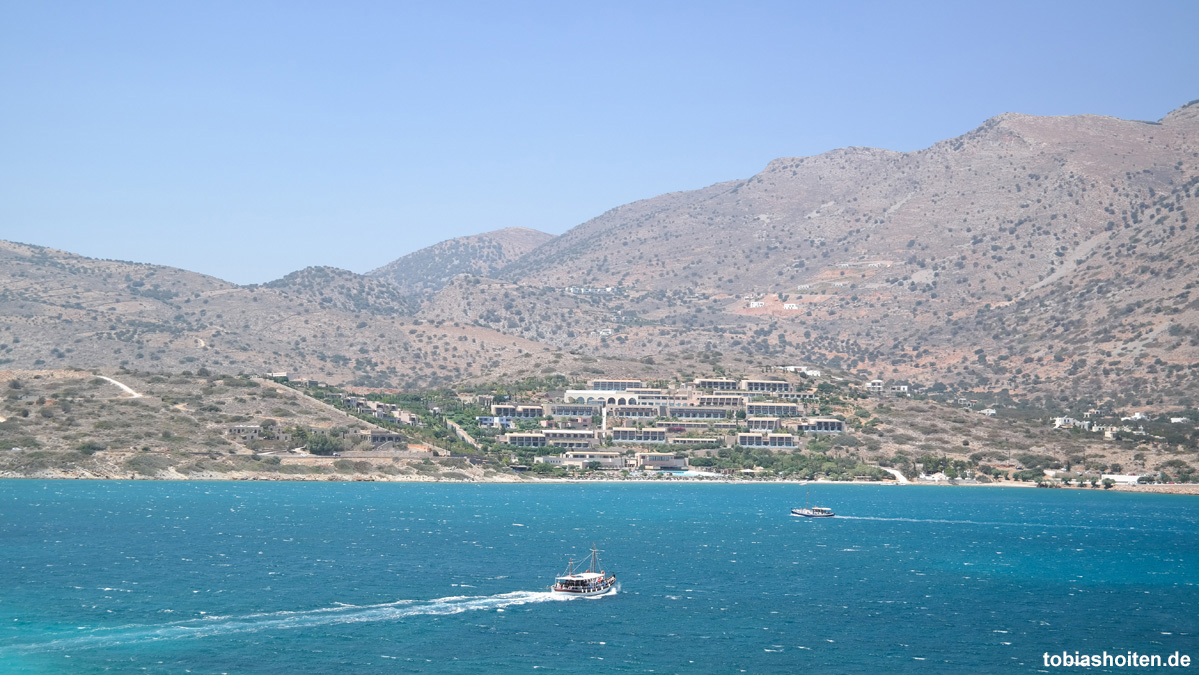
xmin=0 ymin=481 xmax=1199 ymax=674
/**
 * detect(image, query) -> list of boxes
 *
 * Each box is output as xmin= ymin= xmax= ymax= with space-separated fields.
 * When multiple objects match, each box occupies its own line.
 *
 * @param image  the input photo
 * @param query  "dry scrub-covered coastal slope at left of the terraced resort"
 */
xmin=0 ymin=370 xmax=515 ymax=480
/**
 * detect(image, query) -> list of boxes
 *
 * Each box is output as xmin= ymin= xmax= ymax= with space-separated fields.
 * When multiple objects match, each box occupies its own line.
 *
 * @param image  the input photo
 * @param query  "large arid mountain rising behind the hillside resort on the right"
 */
xmin=422 ymin=102 xmax=1199 ymax=403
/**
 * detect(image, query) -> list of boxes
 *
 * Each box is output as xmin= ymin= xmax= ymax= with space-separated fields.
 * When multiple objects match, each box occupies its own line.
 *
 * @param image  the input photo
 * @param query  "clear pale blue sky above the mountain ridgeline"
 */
xmin=0 ymin=0 xmax=1199 ymax=283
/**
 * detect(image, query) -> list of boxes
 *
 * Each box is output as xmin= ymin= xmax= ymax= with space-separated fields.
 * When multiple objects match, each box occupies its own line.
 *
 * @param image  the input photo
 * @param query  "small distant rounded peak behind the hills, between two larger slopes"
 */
xmin=367 ymin=228 xmax=554 ymax=296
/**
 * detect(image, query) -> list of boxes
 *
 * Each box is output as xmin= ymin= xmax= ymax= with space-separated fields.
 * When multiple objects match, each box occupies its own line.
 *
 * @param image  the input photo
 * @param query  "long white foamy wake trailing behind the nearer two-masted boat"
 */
xmin=0 ymin=591 xmax=565 ymax=661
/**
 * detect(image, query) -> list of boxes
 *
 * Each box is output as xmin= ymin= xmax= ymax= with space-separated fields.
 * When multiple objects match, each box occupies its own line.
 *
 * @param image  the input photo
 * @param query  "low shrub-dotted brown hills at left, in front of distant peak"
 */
xmin=0 ymin=241 xmax=561 ymax=387
